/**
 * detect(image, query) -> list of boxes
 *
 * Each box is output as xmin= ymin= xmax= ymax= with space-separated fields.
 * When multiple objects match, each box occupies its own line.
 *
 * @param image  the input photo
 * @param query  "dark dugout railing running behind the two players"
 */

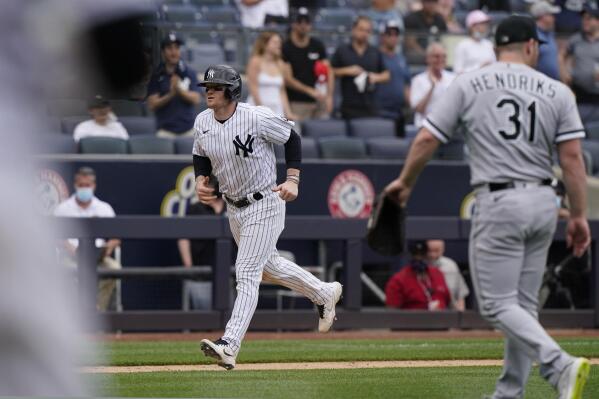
xmin=56 ymin=216 xmax=599 ymax=331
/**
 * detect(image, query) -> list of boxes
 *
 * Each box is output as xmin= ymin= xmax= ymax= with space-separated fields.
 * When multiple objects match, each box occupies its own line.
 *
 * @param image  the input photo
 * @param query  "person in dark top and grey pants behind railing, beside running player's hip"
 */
xmin=177 ymin=176 xmax=225 ymax=310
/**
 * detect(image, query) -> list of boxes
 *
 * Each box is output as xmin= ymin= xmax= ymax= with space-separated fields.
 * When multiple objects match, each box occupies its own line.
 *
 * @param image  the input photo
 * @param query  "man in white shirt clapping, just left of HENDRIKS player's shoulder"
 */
xmin=410 ymin=43 xmax=455 ymax=127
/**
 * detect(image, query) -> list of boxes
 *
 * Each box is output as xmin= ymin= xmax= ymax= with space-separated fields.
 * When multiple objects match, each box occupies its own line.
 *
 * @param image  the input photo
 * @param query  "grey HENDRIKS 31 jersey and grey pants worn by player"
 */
xmin=424 ymin=62 xmax=585 ymax=399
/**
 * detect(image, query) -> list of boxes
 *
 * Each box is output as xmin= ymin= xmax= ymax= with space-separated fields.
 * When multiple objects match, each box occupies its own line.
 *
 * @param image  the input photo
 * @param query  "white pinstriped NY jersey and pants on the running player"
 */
xmin=193 ymin=103 xmax=333 ymax=352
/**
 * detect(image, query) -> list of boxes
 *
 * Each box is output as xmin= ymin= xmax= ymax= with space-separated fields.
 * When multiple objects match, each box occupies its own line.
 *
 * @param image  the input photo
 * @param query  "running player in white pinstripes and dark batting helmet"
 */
xmin=193 ymin=65 xmax=342 ymax=370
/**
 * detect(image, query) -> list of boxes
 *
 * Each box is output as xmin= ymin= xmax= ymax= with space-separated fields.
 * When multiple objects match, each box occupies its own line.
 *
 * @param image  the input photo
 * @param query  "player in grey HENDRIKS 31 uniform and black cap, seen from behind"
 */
xmin=385 ymin=16 xmax=590 ymax=399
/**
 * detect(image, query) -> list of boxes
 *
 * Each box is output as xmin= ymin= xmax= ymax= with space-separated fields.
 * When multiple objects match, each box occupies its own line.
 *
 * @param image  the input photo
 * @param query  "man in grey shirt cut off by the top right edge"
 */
xmin=560 ymin=3 xmax=599 ymax=104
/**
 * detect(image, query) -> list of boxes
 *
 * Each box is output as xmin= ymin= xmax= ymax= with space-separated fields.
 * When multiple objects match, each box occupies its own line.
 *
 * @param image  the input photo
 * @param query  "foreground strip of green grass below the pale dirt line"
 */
xmin=89 ymin=367 xmax=599 ymax=399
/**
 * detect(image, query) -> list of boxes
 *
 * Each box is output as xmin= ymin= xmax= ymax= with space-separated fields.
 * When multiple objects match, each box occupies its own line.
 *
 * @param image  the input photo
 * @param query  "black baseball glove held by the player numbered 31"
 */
xmin=366 ymin=193 xmax=406 ymax=256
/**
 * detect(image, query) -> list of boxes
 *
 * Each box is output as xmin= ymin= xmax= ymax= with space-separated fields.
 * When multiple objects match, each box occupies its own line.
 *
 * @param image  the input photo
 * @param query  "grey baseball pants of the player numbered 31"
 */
xmin=469 ymin=186 xmax=573 ymax=399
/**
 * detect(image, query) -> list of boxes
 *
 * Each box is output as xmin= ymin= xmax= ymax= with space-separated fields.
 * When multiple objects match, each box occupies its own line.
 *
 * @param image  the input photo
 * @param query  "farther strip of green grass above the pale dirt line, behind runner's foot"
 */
xmin=90 ymin=338 xmax=599 ymax=368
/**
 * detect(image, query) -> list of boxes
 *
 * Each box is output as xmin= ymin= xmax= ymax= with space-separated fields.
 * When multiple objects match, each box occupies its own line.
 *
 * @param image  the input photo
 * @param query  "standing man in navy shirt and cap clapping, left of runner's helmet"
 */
xmin=147 ymin=32 xmax=200 ymax=137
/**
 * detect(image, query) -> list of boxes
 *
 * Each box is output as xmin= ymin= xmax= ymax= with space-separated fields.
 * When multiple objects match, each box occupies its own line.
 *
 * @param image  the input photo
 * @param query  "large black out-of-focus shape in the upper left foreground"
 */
xmin=87 ymin=15 xmax=149 ymax=95
